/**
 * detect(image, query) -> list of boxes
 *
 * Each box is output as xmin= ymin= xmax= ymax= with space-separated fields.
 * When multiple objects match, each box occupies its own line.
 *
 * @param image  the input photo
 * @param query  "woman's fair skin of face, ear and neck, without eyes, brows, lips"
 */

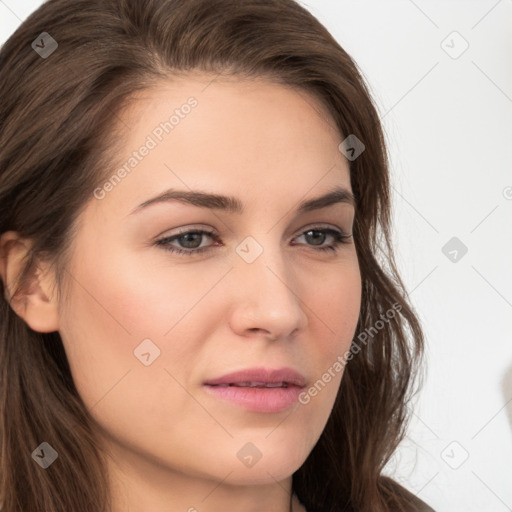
xmin=0 ymin=74 xmax=361 ymax=512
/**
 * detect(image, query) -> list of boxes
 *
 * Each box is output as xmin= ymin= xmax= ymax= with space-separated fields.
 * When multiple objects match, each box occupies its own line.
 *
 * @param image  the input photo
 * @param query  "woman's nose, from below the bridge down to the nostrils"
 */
xmin=230 ymin=242 xmax=307 ymax=341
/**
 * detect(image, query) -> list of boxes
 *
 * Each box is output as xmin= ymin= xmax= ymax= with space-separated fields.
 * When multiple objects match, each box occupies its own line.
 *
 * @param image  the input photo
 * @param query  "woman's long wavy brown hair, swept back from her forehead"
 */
xmin=0 ymin=0 xmax=431 ymax=512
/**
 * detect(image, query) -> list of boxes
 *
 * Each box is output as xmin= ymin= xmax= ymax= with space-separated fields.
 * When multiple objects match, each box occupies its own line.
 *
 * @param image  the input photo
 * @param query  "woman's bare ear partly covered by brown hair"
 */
xmin=0 ymin=231 xmax=59 ymax=332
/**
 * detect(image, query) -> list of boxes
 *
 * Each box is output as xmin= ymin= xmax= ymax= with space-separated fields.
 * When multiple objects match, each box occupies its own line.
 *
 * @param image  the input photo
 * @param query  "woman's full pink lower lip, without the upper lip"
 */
xmin=205 ymin=385 xmax=302 ymax=412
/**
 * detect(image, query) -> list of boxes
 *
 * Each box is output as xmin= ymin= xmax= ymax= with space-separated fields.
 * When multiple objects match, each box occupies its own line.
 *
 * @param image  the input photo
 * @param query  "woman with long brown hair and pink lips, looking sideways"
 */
xmin=0 ymin=0 xmax=432 ymax=512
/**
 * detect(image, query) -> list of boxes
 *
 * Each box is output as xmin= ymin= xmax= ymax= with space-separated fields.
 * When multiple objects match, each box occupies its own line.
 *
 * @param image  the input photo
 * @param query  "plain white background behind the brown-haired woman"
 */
xmin=0 ymin=0 xmax=512 ymax=512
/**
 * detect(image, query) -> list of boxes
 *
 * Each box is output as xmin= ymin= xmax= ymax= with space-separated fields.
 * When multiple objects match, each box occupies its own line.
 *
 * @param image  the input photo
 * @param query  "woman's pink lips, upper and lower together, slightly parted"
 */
xmin=204 ymin=368 xmax=305 ymax=413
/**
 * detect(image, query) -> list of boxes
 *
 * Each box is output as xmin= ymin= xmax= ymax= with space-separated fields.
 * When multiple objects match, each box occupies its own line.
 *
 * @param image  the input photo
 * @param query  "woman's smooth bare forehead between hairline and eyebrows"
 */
xmin=91 ymin=73 xmax=350 ymax=214
